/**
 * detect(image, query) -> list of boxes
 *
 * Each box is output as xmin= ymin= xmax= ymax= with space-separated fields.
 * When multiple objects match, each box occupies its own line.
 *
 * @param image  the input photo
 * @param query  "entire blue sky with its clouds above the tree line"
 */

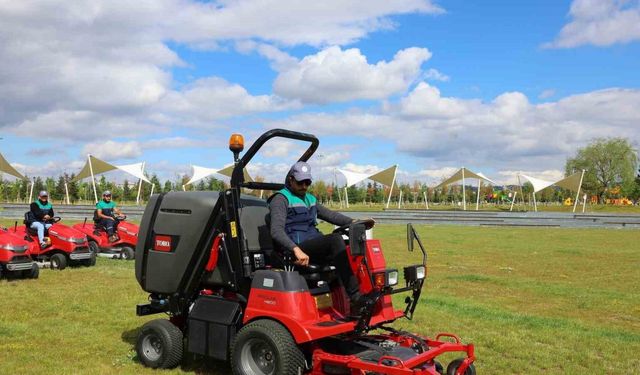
xmin=0 ymin=0 xmax=640 ymax=184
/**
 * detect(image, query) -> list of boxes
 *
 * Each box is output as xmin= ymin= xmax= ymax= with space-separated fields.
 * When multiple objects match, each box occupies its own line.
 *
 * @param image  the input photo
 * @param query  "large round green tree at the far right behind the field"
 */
xmin=565 ymin=138 xmax=638 ymax=202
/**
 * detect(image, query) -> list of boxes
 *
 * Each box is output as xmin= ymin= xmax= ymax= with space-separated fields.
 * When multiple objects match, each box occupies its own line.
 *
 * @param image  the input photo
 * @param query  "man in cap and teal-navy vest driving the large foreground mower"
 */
xmin=268 ymin=161 xmax=372 ymax=309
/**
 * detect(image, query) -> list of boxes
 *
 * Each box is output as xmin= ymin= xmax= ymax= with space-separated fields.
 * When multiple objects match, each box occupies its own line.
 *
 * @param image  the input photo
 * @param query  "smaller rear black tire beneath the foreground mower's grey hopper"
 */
xmin=136 ymin=319 xmax=183 ymax=369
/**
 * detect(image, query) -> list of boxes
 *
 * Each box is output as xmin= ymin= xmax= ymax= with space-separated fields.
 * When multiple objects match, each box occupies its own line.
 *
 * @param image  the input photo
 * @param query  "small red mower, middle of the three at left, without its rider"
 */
xmin=13 ymin=216 xmax=96 ymax=270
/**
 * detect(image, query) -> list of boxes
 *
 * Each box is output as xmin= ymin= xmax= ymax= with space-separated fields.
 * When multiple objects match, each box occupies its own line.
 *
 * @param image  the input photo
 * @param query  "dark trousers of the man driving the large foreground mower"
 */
xmin=298 ymin=233 xmax=360 ymax=297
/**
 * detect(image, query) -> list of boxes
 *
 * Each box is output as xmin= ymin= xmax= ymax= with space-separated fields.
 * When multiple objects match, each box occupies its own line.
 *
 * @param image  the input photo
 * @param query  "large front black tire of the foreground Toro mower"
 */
xmin=231 ymin=319 xmax=305 ymax=375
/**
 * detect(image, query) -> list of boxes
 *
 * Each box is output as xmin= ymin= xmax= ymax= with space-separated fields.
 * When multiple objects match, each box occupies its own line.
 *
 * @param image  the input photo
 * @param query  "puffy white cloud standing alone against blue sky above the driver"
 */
xmin=273 ymin=46 xmax=431 ymax=103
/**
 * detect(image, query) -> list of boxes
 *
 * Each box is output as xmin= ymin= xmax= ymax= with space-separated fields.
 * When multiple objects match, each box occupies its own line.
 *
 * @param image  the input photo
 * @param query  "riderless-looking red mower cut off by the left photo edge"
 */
xmin=0 ymin=228 xmax=40 ymax=279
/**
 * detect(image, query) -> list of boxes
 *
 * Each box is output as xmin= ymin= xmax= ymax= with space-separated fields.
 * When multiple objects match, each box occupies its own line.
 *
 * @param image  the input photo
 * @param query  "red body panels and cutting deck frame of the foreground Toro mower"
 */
xmin=240 ymin=240 xmax=475 ymax=375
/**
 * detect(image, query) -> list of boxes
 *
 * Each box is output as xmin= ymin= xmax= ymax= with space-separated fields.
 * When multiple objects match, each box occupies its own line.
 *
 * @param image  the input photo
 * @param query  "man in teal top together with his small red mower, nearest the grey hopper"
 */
xmin=73 ymin=190 xmax=139 ymax=260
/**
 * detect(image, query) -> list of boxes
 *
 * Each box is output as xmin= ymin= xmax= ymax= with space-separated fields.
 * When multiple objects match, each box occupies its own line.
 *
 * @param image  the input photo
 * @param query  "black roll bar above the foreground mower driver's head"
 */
xmin=231 ymin=129 xmax=320 ymax=190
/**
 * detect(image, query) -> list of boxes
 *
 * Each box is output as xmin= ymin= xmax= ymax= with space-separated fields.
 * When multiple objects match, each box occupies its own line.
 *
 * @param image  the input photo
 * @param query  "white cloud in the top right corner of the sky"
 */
xmin=543 ymin=0 xmax=640 ymax=48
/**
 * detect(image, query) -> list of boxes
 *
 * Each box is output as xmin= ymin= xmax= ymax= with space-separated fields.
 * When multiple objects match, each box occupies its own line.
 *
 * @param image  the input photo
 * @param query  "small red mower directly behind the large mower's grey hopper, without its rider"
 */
xmin=73 ymin=215 xmax=140 ymax=260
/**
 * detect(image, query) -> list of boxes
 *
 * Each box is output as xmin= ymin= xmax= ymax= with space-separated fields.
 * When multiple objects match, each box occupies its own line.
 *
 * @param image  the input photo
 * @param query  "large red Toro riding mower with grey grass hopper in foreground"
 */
xmin=135 ymin=129 xmax=475 ymax=375
